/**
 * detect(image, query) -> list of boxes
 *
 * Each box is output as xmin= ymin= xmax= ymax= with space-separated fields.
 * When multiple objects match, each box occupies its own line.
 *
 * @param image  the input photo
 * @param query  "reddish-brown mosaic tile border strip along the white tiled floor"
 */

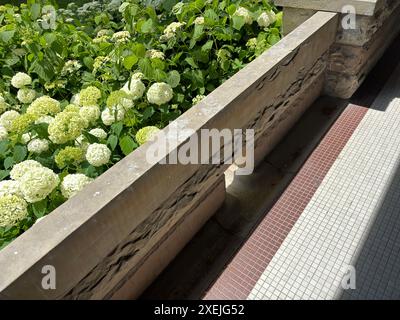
xmin=204 ymin=105 xmax=368 ymax=300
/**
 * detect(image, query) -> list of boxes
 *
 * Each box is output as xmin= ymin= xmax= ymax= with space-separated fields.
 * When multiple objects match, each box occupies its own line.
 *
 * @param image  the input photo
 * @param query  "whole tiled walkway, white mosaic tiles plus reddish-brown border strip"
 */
xmin=205 ymin=63 xmax=400 ymax=299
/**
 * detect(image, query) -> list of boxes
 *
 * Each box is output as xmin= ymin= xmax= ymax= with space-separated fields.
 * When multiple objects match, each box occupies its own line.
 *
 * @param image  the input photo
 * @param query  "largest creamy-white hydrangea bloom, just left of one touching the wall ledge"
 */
xmin=18 ymin=166 xmax=60 ymax=203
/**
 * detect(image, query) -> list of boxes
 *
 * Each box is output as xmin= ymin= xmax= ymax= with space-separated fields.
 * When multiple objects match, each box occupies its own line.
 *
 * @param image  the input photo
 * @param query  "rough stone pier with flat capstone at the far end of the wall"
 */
xmin=275 ymin=0 xmax=400 ymax=98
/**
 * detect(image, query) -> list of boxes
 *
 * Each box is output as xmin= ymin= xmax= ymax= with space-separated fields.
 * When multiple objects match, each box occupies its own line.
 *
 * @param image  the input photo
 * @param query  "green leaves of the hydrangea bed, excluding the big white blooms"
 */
xmin=0 ymin=0 xmax=282 ymax=248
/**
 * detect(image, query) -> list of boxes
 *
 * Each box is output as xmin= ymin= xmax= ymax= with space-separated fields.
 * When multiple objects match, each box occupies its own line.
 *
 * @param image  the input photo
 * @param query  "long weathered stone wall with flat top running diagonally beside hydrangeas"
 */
xmin=0 ymin=12 xmax=337 ymax=299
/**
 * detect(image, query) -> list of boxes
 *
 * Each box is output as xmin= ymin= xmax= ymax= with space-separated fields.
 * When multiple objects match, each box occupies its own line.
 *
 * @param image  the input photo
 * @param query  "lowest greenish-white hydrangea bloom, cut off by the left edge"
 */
xmin=0 ymin=195 xmax=28 ymax=227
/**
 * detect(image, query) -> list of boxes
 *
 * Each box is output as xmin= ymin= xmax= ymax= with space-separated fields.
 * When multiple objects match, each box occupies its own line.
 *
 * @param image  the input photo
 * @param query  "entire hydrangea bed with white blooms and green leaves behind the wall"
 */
xmin=0 ymin=0 xmax=281 ymax=248
